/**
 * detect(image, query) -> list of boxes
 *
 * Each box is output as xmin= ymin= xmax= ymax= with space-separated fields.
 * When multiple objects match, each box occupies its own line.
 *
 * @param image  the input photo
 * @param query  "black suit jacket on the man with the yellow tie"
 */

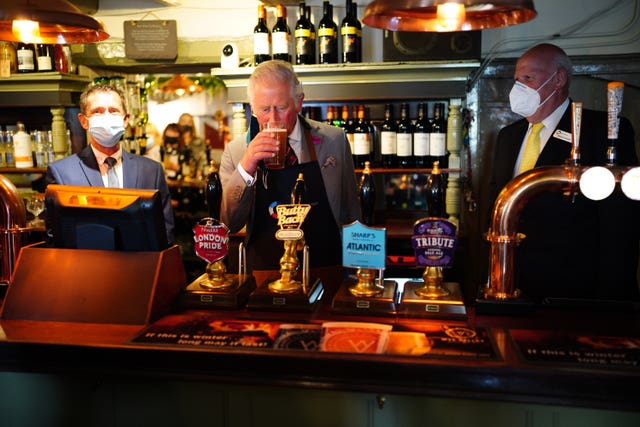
xmin=487 ymin=108 xmax=640 ymax=299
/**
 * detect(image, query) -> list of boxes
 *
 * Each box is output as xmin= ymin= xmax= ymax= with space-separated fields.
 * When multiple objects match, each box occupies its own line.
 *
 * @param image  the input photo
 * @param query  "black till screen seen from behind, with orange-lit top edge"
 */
xmin=45 ymin=184 xmax=169 ymax=251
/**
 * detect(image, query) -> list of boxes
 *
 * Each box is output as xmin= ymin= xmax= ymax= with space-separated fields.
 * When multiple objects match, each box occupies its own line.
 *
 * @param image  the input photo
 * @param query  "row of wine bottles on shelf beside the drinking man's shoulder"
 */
xmin=326 ymin=102 xmax=449 ymax=168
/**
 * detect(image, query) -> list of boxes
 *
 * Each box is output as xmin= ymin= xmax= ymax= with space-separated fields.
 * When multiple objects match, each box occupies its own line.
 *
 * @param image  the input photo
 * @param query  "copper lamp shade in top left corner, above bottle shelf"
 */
xmin=0 ymin=0 xmax=109 ymax=44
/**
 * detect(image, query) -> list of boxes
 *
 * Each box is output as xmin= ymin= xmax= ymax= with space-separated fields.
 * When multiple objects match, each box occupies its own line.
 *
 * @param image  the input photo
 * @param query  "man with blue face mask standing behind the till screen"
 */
xmin=45 ymin=84 xmax=174 ymax=243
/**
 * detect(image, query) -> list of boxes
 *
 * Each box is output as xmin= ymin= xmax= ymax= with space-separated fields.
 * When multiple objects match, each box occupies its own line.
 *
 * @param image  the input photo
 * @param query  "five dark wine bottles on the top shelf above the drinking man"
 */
xmin=253 ymin=0 xmax=362 ymax=65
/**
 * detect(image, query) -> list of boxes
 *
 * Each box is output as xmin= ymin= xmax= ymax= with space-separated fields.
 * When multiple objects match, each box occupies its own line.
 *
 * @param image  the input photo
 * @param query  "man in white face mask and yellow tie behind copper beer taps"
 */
xmin=487 ymin=44 xmax=640 ymax=300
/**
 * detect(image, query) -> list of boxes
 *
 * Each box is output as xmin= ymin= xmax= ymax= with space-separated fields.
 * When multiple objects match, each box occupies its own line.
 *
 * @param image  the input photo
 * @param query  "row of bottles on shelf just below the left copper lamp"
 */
xmin=0 ymin=42 xmax=72 ymax=77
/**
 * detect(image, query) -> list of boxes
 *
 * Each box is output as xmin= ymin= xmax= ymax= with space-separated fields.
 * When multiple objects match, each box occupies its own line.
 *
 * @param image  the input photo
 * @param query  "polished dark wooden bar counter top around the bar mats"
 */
xmin=0 ymin=294 xmax=640 ymax=412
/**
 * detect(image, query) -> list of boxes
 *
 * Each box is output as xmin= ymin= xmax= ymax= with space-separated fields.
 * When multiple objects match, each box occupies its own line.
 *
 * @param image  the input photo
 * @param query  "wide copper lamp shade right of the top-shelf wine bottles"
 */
xmin=362 ymin=0 xmax=537 ymax=32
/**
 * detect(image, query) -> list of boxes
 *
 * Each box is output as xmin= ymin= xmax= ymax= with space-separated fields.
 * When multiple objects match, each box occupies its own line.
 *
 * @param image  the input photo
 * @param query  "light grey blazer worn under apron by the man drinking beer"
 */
xmin=220 ymin=117 xmax=360 ymax=233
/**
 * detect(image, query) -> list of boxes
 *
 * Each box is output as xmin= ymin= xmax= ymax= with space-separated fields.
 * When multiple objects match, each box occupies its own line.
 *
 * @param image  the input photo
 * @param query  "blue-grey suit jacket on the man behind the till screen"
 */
xmin=45 ymin=146 xmax=174 ymax=243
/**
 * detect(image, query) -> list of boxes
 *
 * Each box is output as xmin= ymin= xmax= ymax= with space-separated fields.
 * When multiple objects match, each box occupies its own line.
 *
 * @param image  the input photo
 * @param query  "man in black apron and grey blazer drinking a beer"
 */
xmin=220 ymin=60 xmax=360 ymax=288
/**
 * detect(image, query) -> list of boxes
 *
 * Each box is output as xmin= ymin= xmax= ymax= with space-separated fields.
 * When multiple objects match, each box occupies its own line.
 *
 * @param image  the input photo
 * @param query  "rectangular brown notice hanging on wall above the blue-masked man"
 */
xmin=124 ymin=19 xmax=178 ymax=59
